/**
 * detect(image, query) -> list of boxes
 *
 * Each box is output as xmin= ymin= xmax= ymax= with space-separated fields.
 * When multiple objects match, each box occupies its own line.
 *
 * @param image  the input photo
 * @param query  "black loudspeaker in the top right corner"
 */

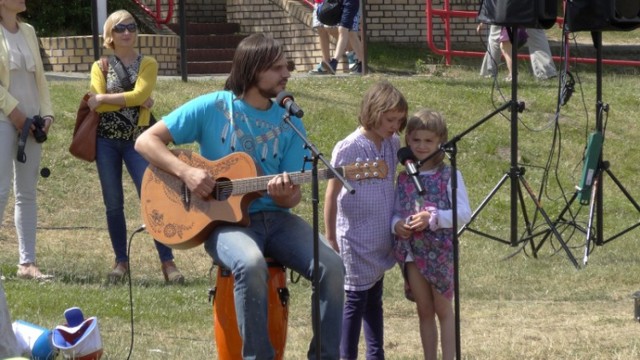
xmin=566 ymin=0 xmax=640 ymax=32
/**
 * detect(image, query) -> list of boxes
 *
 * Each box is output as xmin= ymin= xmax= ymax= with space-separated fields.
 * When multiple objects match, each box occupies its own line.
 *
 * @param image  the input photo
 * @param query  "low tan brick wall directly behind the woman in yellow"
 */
xmin=40 ymin=34 xmax=180 ymax=75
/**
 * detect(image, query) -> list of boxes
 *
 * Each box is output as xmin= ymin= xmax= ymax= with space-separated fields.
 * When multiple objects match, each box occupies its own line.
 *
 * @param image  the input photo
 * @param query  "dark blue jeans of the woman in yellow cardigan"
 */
xmin=96 ymin=137 xmax=173 ymax=262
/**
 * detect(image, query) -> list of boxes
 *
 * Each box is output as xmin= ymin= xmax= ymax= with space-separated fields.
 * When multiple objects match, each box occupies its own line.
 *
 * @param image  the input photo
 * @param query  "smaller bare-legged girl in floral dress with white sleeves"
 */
xmin=392 ymin=109 xmax=471 ymax=360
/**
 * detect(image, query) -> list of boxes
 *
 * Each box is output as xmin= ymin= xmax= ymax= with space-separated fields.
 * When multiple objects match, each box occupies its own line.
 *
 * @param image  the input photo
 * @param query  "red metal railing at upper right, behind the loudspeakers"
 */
xmin=425 ymin=0 xmax=640 ymax=66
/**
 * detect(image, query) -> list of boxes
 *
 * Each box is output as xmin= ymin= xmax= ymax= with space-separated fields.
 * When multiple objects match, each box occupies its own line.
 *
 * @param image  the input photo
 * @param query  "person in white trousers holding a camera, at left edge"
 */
xmin=0 ymin=0 xmax=53 ymax=280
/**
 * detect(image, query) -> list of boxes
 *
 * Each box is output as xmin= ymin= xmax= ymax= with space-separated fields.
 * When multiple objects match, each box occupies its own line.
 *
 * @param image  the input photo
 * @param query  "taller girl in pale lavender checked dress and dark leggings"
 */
xmin=324 ymin=81 xmax=408 ymax=360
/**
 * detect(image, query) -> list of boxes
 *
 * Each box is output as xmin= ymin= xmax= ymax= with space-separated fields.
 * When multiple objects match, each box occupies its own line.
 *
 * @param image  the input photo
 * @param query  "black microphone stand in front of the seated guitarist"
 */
xmin=282 ymin=111 xmax=355 ymax=360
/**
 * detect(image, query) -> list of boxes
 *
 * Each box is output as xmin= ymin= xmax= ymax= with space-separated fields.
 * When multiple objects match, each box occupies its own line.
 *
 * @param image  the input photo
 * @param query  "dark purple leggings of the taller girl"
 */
xmin=340 ymin=278 xmax=384 ymax=360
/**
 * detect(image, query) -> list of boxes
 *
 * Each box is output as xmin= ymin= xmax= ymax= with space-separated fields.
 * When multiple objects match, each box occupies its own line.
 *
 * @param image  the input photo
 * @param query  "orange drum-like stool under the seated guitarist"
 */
xmin=213 ymin=258 xmax=289 ymax=360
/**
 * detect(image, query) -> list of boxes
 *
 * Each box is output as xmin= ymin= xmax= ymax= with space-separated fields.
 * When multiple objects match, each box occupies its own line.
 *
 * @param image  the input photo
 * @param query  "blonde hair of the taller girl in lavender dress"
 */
xmin=358 ymin=81 xmax=409 ymax=132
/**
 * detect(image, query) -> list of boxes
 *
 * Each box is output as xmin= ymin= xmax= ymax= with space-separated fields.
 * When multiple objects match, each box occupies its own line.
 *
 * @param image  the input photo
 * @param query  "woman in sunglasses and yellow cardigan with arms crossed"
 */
xmin=88 ymin=10 xmax=184 ymax=284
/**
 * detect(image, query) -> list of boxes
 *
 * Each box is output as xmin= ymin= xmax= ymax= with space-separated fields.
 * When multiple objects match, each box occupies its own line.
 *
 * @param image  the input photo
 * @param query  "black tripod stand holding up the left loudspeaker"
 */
xmin=458 ymin=26 xmax=579 ymax=267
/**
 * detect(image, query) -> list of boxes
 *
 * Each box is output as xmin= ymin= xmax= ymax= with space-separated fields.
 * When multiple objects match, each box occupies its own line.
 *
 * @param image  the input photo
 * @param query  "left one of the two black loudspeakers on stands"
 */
xmin=478 ymin=0 xmax=556 ymax=29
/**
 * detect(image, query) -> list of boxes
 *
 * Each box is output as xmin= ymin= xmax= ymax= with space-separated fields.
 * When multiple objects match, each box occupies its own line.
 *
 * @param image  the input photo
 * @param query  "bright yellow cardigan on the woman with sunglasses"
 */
xmin=91 ymin=56 xmax=158 ymax=126
